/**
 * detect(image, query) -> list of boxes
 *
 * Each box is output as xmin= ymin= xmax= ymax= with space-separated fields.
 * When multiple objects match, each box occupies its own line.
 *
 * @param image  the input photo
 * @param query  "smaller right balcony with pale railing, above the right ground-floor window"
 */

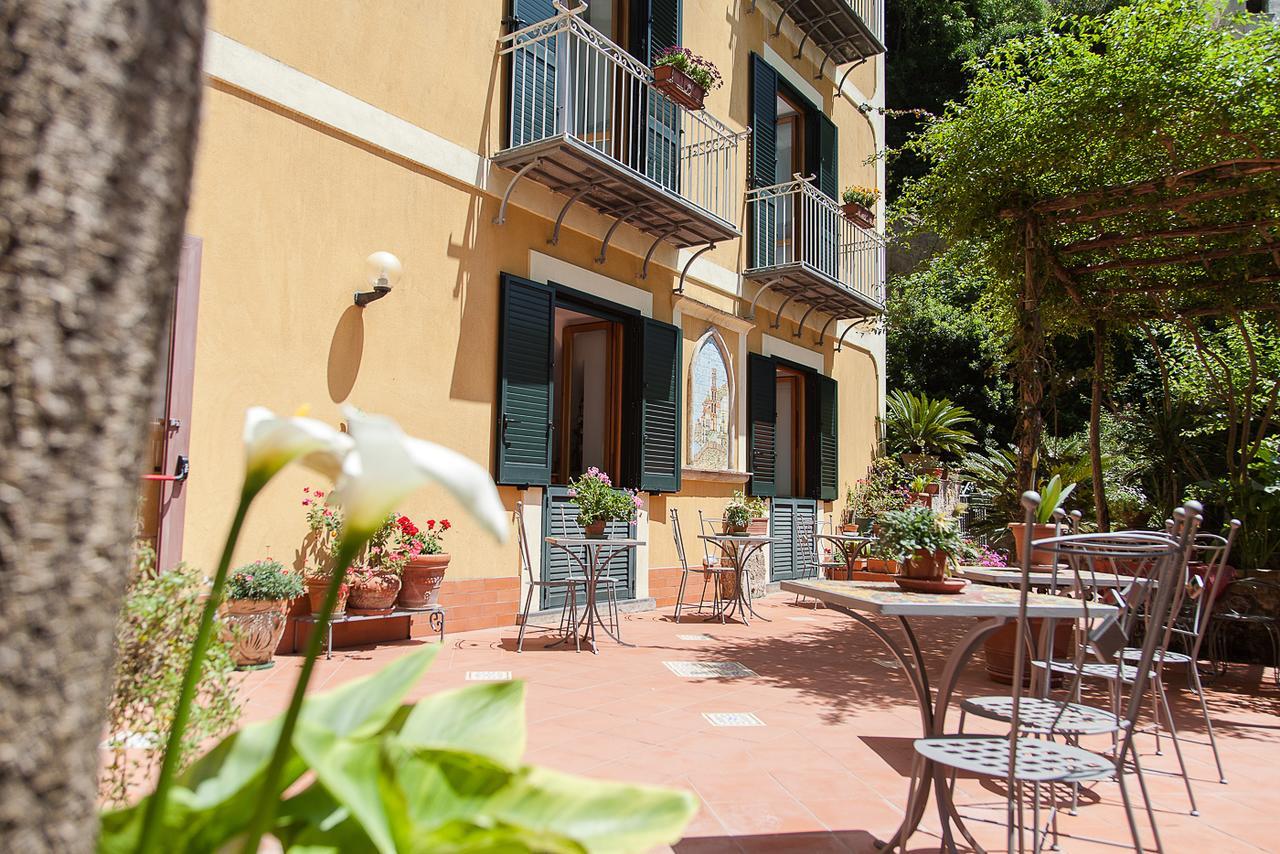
xmin=742 ymin=175 xmax=884 ymax=323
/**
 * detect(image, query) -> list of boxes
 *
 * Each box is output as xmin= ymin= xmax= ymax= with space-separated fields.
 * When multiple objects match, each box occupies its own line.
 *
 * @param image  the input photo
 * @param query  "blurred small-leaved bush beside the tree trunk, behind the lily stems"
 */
xmin=99 ymin=547 xmax=239 ymax=805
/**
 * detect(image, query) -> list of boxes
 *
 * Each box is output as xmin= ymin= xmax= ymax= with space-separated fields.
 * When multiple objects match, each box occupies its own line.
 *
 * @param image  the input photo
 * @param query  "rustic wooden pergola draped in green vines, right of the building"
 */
xmin=1001 ymin=156 xmax=1280 ymax=529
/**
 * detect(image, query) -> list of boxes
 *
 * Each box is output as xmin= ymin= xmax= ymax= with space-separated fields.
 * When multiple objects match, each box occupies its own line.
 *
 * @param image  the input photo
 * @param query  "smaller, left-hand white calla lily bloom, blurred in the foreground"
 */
xmin=244 ymin=406 xmax=353 ymax=492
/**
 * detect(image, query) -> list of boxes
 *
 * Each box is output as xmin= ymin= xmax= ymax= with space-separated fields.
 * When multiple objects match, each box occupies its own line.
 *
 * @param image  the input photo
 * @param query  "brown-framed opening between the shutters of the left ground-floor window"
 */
xmin=553 ymin=307 xmax=623 ymax=484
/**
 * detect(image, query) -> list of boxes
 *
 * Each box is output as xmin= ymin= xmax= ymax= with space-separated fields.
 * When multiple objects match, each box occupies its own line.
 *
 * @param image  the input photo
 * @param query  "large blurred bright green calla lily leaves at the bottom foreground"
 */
xmin=99 ymin=645 xmax=698 ymax=854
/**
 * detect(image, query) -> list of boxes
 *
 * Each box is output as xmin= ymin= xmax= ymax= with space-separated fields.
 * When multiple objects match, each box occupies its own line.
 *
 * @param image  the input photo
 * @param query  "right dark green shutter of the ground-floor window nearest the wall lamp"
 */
xmin=640 ymin=318 xmax=682 ymax=492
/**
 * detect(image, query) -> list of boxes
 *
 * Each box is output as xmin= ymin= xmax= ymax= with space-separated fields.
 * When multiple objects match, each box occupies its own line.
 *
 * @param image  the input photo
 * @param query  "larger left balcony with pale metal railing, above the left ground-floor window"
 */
xmin=493 ymin=4 xmax=746 ymax=257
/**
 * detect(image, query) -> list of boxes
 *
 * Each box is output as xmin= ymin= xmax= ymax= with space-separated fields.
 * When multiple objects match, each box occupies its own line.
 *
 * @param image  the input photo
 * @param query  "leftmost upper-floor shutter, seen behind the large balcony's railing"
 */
xmin=507 ymin=0 xmax=558 ymax=147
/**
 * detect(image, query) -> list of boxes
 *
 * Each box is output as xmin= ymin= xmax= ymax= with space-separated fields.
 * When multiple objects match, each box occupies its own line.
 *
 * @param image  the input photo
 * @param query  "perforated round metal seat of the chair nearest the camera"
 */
xmin=915 ymin=735 xmax=1115 ymax=782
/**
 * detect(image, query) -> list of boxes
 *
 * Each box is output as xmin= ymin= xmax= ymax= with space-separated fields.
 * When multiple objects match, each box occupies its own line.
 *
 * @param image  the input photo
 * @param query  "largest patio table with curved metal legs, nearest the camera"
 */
xmin=782 ymin=580 xmax=1115 ymax=851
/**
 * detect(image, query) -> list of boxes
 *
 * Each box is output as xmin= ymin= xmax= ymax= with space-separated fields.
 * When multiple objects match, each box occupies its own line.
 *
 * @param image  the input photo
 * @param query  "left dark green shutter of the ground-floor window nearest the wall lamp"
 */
xmin=497 ymin=274 xmax=556 ymax=487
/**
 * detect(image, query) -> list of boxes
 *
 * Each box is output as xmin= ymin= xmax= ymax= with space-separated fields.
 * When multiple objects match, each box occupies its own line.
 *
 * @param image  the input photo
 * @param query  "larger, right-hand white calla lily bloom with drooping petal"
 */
xmin=332 ymin=407 xmax=507 ymax=540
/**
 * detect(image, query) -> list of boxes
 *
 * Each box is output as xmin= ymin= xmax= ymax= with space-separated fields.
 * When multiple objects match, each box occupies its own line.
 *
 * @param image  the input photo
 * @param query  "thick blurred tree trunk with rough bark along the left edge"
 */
xmin=0 ymin=0 xmax=204 ymax=851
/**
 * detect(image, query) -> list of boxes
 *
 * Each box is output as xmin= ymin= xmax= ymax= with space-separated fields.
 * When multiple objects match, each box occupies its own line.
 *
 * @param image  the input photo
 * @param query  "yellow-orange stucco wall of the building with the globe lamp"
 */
xmin=183 ymin=0 xmax=878 ymax=579
